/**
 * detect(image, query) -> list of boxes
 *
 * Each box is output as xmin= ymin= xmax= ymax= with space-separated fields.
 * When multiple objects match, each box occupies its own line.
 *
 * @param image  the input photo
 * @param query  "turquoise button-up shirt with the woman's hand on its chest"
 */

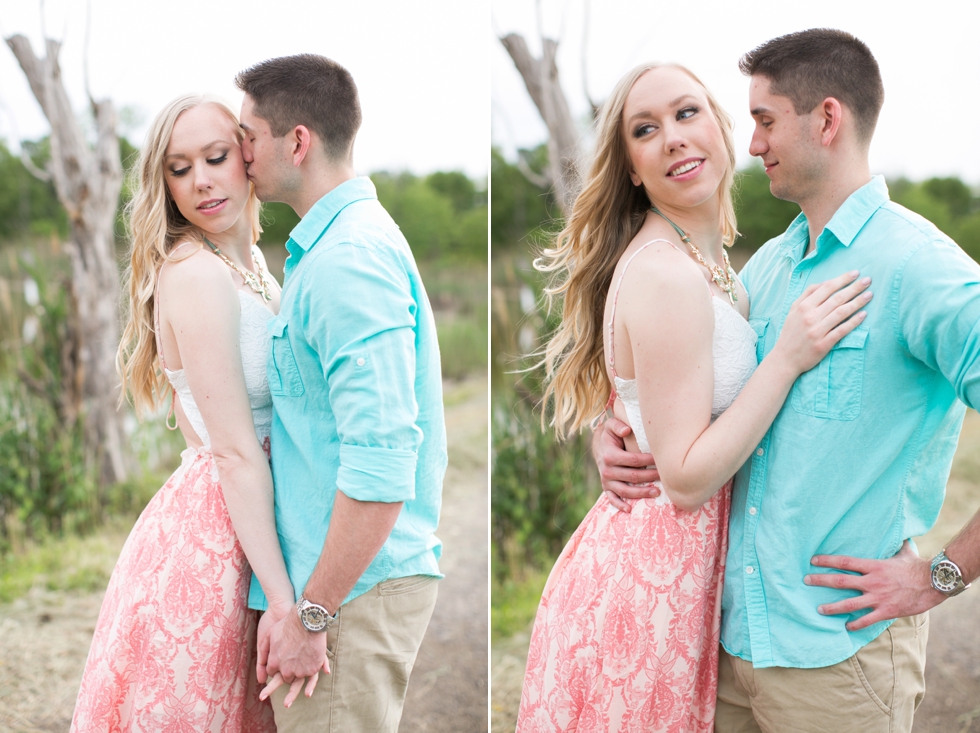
xmin=722 ymin=177 xmax=980 ymax=667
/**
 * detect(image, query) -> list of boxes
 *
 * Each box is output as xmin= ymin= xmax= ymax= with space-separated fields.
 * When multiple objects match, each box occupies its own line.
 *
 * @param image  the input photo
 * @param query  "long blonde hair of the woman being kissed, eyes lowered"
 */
xmin=116 ymin=94 xmax=262 ymax=416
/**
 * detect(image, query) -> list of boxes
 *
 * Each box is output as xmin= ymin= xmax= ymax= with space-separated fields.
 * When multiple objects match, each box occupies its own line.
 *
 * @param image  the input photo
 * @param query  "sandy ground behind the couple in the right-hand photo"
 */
xmin=490 ymin=410 xmax=980 ymax=733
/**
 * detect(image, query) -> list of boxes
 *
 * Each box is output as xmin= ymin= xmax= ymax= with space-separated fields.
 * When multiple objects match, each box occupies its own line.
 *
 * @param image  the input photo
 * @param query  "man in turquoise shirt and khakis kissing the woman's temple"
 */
xmin=236 ymin=54 xmax=446 ymax=733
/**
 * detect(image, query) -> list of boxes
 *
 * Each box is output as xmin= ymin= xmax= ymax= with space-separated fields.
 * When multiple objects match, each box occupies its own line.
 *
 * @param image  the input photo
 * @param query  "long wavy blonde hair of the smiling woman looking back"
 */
xmin=534 ymin=64 xmax=738 ymax=438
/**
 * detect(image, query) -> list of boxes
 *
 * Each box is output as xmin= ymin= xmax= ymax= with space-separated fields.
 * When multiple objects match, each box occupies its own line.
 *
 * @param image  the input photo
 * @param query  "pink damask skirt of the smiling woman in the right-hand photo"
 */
xmin=517 ymin=482 xmax=731 ymax=733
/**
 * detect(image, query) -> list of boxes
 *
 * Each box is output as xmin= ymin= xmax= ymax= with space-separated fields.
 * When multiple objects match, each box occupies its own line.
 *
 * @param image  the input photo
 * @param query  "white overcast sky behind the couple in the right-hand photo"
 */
xmin=489 ymin=0 xmax=980 ymax=186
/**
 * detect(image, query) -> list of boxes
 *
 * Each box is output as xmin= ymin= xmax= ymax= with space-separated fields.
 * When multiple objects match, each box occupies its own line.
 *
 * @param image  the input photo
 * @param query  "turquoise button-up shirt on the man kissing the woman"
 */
xmin=249 ymin=178 xmax=446 ymax=609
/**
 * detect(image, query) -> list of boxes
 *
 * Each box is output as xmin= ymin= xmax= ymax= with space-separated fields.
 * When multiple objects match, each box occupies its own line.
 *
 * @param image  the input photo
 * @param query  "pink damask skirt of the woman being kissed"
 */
xmin=71 ymin=449 xmax=276 ymax=733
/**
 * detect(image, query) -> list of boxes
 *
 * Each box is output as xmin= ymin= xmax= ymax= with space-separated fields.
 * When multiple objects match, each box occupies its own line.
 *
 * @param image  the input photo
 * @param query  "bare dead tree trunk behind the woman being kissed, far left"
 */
xmin=6 ymin=35 xmax=126 ymax=484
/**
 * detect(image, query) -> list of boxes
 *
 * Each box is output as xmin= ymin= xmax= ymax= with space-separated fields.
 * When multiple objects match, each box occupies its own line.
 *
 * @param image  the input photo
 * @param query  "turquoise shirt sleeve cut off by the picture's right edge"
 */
xmin=894 ymin=240 xmax=980 ymax=409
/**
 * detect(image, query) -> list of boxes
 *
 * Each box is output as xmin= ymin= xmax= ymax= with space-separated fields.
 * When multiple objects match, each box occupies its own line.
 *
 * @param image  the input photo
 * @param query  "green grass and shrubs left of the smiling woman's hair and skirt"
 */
xmin=490 ymin=253 xmax=600 ymax=640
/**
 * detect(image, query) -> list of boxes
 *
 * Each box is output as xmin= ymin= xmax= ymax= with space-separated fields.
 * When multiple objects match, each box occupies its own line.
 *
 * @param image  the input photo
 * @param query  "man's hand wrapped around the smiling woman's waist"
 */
xmin=592 ymin=417 xmax=660 ymax=512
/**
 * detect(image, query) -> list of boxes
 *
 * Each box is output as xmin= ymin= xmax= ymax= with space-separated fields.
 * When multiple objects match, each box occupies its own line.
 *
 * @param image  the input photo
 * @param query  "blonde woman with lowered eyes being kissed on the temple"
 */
xmin=72 ymin=96 xmax=326 ymax=732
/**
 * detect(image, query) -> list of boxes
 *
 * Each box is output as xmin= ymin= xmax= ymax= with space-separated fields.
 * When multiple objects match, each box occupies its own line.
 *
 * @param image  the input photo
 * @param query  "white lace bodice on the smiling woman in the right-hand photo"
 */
xmin=614 ymin=296 xmax=758 ymax=453
